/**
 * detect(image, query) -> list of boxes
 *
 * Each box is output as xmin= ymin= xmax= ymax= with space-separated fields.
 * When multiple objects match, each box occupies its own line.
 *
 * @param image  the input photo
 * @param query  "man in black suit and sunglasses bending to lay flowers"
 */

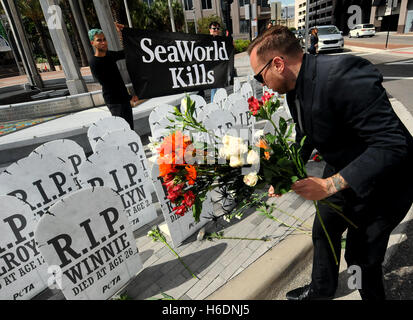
xmin=248 ymin=26 xmax=413 ymax=300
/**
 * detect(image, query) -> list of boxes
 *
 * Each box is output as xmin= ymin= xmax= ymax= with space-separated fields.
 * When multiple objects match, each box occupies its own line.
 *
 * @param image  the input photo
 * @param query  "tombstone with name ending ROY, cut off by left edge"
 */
xmin=0 ymin=196 xmax=48 ymax=300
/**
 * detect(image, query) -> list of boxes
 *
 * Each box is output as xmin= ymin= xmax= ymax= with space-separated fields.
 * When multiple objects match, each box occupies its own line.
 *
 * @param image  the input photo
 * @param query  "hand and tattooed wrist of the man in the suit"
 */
xmin=291 ymin=173 xmax=349 ymax=200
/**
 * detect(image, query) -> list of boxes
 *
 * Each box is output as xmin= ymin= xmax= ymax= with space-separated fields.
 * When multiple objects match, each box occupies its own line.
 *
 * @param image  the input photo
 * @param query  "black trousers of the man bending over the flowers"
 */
xmin=311 ymin=166 xmax=413 ymax=300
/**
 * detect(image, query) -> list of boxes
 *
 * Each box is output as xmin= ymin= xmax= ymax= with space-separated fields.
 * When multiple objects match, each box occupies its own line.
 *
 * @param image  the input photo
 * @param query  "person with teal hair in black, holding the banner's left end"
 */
xmin=89 ymin=24 xmax=138 ymax=130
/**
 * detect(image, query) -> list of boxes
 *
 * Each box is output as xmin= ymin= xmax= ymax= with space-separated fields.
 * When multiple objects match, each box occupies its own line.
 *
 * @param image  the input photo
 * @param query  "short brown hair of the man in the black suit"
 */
xmin=248 ymin=25 xmax=303 ymax=60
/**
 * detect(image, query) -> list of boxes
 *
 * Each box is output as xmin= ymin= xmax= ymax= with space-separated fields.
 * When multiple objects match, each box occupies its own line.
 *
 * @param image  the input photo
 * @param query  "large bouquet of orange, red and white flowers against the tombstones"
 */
xmin=157 ymin=92 xmax=347 ymax=261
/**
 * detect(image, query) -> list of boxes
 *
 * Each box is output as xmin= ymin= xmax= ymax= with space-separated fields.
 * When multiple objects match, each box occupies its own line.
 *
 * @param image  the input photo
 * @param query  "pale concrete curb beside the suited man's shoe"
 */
xmin=207 ymin=235 xmax=313 ymax=300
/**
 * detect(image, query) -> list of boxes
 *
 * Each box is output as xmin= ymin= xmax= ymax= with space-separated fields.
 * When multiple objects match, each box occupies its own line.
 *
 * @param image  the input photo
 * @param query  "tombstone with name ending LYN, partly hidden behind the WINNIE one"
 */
xmin=78 ymin=146 xmax=157 ymax=231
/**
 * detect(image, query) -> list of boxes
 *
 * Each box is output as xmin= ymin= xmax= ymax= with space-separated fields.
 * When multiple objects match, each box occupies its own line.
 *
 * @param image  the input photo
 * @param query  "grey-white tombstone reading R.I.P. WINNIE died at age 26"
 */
xmin=34 ymin=187 xmax=143 ymax=300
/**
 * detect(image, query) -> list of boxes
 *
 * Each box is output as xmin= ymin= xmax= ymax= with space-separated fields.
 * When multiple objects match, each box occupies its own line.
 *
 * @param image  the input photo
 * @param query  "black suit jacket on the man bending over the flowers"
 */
xmin=287 ymin=54 xmax=413 ymax=203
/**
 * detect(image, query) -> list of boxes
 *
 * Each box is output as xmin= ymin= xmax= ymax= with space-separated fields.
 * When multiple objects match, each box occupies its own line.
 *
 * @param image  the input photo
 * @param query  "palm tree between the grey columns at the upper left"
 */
xmin=17 ymin=0 xmax=56 ymax=71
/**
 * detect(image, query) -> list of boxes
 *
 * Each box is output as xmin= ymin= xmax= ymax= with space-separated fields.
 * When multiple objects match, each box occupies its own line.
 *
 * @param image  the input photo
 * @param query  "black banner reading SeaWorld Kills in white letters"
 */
xmin=122 ymin=28 xmax=234 ymax=99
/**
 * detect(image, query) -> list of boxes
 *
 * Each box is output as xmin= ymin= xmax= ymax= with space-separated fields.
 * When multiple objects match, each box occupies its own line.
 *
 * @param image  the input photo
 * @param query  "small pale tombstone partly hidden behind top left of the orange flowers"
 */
xmin=149 ymin=104 xmax=175 ymax=141
